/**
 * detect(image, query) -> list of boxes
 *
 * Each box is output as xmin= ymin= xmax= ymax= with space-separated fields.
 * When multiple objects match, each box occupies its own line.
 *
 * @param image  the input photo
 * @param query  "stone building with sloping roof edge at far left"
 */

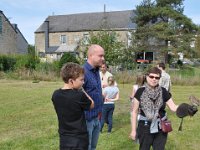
xmin=0 ymin=10 xmax=28 ymax=54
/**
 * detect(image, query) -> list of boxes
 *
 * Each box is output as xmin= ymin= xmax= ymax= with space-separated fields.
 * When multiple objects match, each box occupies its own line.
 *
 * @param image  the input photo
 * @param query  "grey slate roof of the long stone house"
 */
xmin=35 ymin=10 xmax=136 ymax=33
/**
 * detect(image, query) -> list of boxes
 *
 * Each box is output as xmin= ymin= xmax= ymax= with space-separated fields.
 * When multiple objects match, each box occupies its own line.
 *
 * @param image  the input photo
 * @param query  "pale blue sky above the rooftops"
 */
xmin=0 ymin=0 xmax=200 ymax=44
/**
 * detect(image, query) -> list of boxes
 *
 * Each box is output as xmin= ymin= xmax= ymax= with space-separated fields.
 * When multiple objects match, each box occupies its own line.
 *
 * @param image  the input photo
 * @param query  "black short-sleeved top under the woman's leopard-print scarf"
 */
xmin=134 ymin=87 xmax=171 ymax=117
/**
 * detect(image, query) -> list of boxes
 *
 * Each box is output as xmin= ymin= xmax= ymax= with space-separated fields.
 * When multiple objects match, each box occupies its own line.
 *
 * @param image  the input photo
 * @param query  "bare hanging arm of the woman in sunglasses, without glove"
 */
xmin=130 ymin=98 xmax=139 ymax=140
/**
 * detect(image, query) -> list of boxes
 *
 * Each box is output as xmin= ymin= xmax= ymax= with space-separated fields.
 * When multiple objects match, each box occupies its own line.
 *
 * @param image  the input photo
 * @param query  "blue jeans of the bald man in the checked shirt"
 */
xmin=86 ymin=117 xmax=100 ymax=150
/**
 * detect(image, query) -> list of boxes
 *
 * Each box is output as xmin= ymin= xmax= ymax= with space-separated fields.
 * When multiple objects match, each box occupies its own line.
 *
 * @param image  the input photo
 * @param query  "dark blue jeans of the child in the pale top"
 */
xmin=101 ymin=104 xmax=115 ymax=132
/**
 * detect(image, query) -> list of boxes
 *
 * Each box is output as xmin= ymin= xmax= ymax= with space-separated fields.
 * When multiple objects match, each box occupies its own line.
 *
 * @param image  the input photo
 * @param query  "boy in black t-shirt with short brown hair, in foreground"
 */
xmin=52 ymin=63 xmax=94 ymax=150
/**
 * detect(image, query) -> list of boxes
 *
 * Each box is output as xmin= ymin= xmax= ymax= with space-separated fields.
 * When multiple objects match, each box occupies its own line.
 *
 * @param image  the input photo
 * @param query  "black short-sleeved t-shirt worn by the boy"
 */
xmin=52 ymin=89 xmax=91 ymax=144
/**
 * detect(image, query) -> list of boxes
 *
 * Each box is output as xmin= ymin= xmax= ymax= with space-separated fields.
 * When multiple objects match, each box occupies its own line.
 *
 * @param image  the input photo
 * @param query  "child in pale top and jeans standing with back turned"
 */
xmin=101 ymin=76 xmax=119 ymax=133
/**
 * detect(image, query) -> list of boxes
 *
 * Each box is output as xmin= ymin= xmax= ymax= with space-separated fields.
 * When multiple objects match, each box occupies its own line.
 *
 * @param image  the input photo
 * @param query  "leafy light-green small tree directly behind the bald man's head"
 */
xmin=77 ymin=30 xmax=130 ymax=66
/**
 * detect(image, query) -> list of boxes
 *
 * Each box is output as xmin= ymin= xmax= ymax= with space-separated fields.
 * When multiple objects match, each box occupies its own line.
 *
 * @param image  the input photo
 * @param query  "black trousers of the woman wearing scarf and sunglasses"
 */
xmin=137 ymin=121 xmax=167 ymax=150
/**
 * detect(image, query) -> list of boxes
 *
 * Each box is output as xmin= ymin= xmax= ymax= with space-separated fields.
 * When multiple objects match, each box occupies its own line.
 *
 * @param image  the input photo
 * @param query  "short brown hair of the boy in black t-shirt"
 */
xmin=60 ymin=62 xmax=84 ymax=83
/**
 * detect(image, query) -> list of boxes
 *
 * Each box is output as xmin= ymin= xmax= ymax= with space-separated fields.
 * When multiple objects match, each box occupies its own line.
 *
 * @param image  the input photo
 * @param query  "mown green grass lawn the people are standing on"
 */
xmin=0 ymin=80 xmax=200 ymax=150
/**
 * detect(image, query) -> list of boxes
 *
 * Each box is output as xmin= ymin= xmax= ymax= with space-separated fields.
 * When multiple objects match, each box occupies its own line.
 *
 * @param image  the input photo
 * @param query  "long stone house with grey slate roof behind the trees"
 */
xmin=35 ymin=10 xmax=136 ymax=60
